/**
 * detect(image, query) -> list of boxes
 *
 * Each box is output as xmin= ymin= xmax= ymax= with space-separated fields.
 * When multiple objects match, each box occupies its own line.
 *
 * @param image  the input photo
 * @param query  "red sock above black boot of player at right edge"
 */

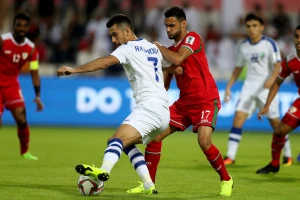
xmin=271 ymin=134 xmax=285 ymax=167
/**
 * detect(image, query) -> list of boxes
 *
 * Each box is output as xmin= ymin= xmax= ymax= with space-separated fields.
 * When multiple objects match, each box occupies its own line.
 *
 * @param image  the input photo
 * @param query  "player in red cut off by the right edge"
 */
xmin=256 ymin=25 xmax=300 ymax=174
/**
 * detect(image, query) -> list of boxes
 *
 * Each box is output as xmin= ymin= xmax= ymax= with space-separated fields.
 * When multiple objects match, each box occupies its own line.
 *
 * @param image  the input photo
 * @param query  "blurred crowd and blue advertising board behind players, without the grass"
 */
xmin=0 ymin=0 xmax=300 ymax=130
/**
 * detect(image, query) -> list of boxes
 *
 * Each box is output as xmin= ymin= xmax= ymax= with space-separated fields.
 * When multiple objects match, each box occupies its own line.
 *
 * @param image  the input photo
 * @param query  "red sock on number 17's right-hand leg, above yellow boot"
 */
xmin=204 ymin=145 xmax=231 ymax=181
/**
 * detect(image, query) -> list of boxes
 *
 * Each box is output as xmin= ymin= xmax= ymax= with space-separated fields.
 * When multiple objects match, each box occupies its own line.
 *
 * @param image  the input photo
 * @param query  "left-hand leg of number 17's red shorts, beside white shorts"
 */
xmin=170 ymin=101 xmax=192 ymax=131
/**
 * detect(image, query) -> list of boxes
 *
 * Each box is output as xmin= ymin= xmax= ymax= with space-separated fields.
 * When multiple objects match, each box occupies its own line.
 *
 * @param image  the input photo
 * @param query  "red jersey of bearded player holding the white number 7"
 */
xmin=169 ymin=32 xmax=219 ymax=104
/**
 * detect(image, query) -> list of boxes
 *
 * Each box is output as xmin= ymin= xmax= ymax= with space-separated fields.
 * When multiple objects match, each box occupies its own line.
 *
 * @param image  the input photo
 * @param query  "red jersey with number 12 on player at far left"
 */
xmin=0 ymin=33 xmax=38 ymax=85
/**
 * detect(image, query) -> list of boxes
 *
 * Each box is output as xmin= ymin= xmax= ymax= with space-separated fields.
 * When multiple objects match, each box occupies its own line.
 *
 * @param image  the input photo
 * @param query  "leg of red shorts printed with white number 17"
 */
xmin=188 ymin=99 xmax=221 ymax=133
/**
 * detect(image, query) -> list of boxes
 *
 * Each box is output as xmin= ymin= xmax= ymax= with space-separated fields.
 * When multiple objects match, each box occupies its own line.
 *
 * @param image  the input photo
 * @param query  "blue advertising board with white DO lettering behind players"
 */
xmin=3 ymin=76 xmax=299 ymax=131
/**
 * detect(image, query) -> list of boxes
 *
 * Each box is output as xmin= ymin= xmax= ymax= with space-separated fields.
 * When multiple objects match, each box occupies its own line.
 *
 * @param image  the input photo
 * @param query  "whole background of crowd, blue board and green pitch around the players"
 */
xmin=0 ymin=0 xmax=300 ymax=200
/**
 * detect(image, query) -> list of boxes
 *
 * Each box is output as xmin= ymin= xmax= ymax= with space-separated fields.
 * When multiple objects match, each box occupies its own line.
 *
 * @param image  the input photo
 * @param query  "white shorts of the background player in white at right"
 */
xmin=236 ymin=89 xmax=280 ymax=119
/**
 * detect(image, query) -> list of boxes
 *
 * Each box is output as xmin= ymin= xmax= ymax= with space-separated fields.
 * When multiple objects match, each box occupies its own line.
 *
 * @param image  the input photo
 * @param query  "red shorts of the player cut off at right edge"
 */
xmin=281 ymin=98 xmax=300 ymax=129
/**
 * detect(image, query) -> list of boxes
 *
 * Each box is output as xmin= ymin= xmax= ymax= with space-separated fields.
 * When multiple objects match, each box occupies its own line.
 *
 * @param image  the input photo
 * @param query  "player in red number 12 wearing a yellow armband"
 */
xmin=0 ymin=13 xmax=43 ymax=160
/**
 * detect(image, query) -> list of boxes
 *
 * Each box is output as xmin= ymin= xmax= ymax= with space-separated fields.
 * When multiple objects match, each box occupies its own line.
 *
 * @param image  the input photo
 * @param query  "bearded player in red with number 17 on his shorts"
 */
xmin=127 ymin=7 xmax=233 ymax=196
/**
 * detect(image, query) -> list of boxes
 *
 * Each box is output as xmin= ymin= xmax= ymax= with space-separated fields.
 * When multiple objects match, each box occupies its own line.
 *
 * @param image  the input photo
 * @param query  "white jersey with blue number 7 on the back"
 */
xmin=111 ymin=39 xmax=170 ymax=103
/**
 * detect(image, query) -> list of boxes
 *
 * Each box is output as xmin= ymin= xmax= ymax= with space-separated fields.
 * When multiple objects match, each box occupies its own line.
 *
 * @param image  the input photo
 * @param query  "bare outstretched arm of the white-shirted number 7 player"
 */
xmin=57 ymin=55 xmax=120 ymax=76
